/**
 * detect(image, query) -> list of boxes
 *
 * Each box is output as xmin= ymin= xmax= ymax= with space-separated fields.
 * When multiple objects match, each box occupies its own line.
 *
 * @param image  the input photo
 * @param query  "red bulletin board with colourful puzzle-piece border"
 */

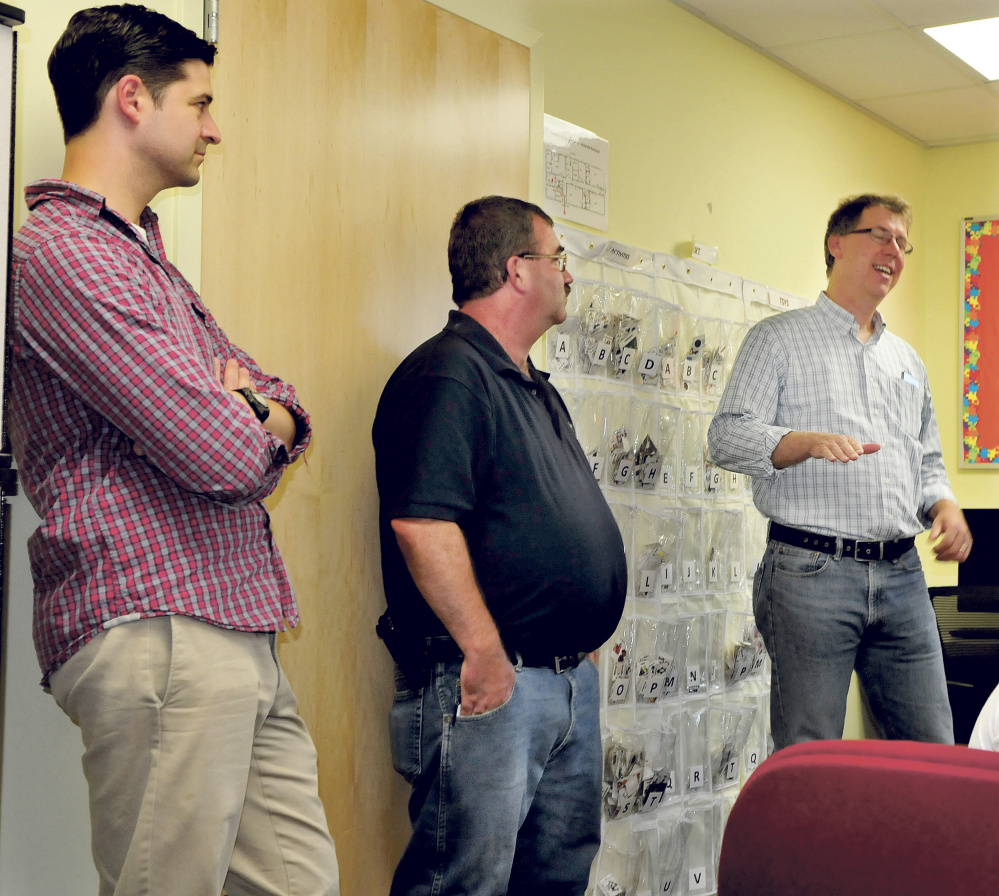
xmin=960 ymin=216 xmax=999 ymax=469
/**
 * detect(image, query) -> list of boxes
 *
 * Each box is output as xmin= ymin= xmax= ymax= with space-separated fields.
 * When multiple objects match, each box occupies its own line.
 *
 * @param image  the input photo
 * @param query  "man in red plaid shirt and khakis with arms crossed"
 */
xmin=10 ymin=5 xmax=339 ymax=896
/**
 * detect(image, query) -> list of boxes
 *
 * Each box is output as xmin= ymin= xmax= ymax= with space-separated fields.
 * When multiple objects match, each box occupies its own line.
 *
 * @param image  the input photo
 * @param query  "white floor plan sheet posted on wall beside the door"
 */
xmin=544 ymin=115 xmax=608 ymax=230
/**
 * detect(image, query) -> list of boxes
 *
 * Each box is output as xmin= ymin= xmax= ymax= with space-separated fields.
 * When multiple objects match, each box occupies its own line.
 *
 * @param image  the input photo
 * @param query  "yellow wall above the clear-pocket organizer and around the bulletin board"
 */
xmin=435 ymin=0 xmax=999 ymax=585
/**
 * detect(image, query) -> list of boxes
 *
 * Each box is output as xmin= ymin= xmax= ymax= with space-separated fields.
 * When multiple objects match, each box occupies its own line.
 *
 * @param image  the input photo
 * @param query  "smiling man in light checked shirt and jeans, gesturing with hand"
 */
xmin=708 ymin=195 xmax=971 ymax=749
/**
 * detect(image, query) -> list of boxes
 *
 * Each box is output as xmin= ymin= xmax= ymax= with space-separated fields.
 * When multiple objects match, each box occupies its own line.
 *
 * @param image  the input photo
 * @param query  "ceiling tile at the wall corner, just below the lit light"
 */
xmin=862 ymin=85 xmax=999 ymax=146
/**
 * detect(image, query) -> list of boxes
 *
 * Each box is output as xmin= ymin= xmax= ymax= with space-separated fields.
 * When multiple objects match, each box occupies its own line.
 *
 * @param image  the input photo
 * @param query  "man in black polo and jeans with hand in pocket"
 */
xmin=372 ymin=196 xmax=627 ymax=896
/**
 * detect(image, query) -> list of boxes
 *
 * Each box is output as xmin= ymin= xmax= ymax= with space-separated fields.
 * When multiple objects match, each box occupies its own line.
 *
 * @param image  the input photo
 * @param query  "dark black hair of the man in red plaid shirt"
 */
xmin=49 ymin=3 xmax=215 ymax=143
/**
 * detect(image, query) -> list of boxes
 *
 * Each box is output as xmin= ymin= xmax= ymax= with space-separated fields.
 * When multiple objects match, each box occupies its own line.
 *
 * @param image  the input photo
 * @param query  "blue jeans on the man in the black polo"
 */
xmin=391 ymin=660 xmax=602 ymax=896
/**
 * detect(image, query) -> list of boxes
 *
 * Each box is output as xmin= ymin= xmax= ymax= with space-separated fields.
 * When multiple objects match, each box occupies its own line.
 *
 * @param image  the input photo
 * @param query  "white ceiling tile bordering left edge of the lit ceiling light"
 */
xmin=771 ymin=29 xmax=976 ymax=100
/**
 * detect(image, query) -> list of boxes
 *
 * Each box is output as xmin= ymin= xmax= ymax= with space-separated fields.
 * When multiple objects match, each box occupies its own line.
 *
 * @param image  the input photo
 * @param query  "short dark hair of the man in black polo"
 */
xmin=447 ymin=196 xmax=552 ymax=308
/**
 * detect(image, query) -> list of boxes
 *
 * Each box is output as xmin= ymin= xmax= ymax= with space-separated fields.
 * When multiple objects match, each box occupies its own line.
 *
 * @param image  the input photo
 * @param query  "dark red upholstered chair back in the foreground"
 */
xmin=718 ymin=740 xmax=999 ymax=896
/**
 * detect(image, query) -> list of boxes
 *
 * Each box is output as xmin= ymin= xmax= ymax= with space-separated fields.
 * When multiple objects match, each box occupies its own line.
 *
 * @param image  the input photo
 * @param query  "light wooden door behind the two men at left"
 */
xmin=202 ymin=0 xmax=530 ymax=896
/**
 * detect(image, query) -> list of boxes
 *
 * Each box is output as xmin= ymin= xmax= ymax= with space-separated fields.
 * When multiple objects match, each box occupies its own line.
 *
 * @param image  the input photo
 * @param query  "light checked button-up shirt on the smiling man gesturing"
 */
xmin=708 ymin=293 xmax=954 ymax=541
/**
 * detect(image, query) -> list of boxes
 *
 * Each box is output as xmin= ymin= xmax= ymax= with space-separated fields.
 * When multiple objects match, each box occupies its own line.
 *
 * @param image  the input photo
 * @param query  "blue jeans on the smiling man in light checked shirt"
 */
xmin=753 ymin=541 xmax=954 ymax=750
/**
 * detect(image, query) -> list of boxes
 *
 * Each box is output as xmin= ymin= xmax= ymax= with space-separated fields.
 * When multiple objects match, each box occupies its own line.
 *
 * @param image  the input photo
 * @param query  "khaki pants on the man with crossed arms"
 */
xmin=51 ymin=616 xmax=339 ymax=896
